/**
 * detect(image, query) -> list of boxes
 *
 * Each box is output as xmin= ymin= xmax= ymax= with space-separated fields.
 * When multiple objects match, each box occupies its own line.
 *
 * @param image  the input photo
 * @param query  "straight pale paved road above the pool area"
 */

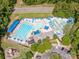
xmin=13 ymin=7 xmax=54 ymax=13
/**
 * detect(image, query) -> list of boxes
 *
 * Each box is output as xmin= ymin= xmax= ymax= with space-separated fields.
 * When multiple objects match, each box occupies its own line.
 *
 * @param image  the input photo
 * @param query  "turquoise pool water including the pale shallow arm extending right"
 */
xmin=13 ymin=23 xmax=43 ymax=41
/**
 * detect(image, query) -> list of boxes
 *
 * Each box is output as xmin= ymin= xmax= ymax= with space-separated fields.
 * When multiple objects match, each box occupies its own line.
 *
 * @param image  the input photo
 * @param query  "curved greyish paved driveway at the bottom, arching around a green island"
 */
xmin=41 ymin=46 xmax=72 ymax=59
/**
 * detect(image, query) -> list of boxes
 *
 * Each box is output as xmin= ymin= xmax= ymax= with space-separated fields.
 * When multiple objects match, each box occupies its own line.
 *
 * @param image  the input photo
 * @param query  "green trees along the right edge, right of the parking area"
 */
xmin=71 ymin=28 xmax=79 ymax=56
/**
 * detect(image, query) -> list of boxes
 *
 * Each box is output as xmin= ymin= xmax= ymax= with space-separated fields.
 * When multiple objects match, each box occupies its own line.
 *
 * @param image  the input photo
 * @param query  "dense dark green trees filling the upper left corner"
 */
xmin=0 ymin=0 xmax=16 ymax=33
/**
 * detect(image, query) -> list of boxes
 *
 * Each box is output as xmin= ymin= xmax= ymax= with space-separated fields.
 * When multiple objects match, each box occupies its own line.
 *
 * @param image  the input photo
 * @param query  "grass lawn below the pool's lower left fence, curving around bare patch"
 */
xmin=2 ymin=40 xmax=30 ymax=59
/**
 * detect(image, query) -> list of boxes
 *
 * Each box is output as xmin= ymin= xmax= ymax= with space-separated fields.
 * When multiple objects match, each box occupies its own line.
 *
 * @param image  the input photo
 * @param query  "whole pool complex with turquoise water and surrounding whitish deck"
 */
xmin=10 ymin=18 xmax=74 ymax=43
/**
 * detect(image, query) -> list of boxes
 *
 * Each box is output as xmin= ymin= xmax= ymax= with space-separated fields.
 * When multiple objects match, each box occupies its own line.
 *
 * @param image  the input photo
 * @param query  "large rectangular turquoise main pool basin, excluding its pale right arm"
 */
xmin=14 ymin=23 xmax=33 ymax=40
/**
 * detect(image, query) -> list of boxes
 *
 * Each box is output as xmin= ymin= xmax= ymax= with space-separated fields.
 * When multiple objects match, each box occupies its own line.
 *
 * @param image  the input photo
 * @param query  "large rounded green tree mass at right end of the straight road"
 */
xmin=53 ymin=2 xmax=74 ymax=18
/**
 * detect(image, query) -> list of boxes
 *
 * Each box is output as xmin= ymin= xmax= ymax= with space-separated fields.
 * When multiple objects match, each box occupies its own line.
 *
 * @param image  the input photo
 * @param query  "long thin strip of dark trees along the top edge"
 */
xmin=23 ymin=0 xmax=79 ymax=5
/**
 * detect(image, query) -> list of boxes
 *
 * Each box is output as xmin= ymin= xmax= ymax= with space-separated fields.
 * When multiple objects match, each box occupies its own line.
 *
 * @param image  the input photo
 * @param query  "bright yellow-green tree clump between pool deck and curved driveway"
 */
xmin=31 ymin=38 xmax=52 ymax=53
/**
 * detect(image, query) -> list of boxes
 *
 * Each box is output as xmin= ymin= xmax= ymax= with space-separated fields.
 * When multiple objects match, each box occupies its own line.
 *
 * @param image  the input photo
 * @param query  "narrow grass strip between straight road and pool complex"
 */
xmin=11 ymin=13 xmax=52 ymax=19
